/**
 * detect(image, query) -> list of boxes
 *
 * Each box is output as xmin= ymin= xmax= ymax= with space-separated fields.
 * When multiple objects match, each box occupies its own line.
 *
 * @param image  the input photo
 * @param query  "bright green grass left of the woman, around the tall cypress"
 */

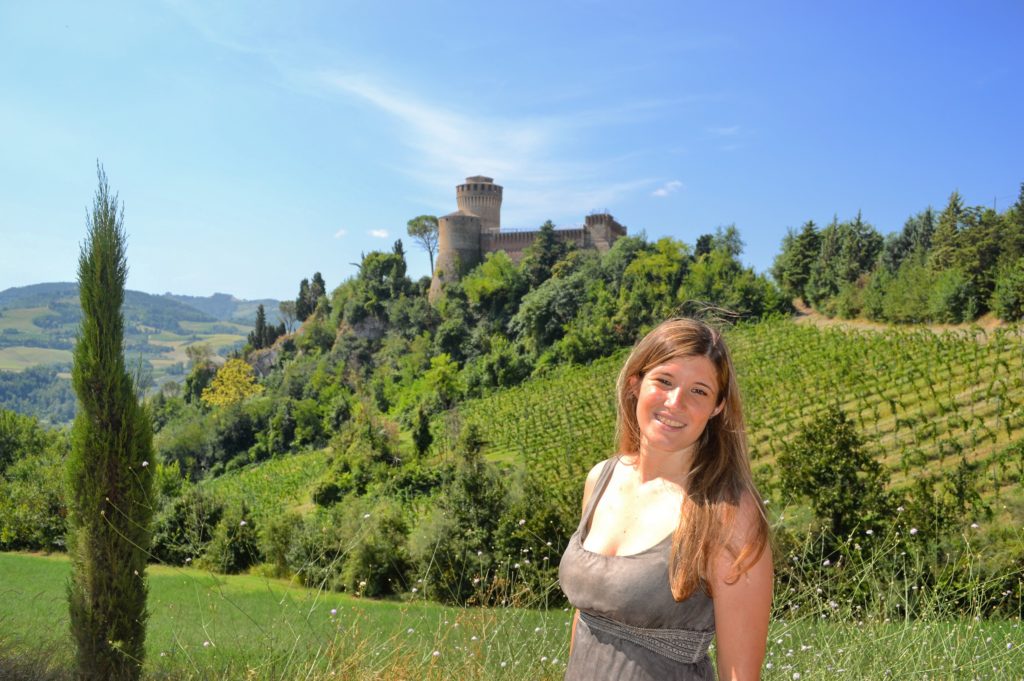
xmin=0 ymin=554 xmax=570 ymax=680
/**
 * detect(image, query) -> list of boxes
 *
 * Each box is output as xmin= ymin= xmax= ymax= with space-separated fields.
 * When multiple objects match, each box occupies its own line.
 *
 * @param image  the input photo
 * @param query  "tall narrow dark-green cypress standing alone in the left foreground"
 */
xmin=68 ymin=164 xmax=154 ymax=681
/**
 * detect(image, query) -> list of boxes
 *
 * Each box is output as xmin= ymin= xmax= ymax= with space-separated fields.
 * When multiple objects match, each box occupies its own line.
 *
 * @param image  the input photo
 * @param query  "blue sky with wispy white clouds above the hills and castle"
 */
xmin=0 ymin=0 xmax=1024 ymax=298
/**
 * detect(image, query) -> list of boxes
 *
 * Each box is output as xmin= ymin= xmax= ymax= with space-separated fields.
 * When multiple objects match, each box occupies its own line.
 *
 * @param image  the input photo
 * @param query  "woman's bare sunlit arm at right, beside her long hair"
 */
xmin=712 ymin=499 xmax=774 ymax=681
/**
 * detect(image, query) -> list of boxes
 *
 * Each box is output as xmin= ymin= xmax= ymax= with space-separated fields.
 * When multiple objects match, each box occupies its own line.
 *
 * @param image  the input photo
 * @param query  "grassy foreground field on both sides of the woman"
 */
xmin=0 ymin=554 xmax=1024 ymax=681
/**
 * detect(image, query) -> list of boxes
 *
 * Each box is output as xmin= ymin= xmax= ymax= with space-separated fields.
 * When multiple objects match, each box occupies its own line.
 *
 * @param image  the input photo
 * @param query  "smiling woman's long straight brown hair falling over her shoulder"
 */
xmin=615 ymin=318 xmax=769 ymax=601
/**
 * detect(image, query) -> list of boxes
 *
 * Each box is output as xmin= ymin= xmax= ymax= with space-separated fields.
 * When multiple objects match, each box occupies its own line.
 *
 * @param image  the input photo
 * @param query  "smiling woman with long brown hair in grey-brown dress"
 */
xmin=559 ymin=320 xmax=772 ymax=681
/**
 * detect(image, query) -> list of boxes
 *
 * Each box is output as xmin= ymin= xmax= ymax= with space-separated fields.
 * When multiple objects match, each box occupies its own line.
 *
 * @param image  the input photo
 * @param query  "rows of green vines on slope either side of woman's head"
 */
xmin=434 ymin=320 xmax=1024 ymax=520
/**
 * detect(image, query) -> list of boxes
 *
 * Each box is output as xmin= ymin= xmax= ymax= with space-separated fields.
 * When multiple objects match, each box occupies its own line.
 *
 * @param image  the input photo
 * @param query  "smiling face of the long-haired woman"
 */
xmin=637 ymin=355 xmax=722 ymax=453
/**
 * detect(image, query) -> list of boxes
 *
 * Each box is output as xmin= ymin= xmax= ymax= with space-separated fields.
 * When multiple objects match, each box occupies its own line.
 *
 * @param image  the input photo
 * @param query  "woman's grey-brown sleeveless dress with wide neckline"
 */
xmin=558 ymin=457 xmax=715 ymax=681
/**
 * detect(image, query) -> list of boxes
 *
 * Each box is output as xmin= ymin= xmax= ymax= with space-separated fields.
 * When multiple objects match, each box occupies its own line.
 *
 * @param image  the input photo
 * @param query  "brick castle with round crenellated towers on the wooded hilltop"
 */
xmin=430 ymin=175 xmax=626 ymax=300
